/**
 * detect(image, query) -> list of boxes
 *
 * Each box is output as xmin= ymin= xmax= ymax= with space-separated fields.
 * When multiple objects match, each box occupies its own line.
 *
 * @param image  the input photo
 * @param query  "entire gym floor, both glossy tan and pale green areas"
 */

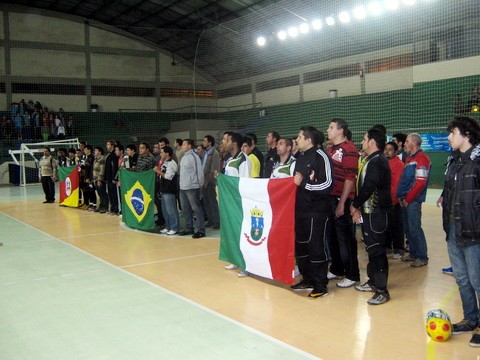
xmin=0 ymin=186 xmax=480 ymax=360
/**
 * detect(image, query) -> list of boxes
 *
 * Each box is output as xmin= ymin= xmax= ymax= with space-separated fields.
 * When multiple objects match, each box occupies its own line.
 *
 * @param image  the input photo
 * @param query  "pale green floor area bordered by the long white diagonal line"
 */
xmin=0 ymin=210 xmax=313 ymax=360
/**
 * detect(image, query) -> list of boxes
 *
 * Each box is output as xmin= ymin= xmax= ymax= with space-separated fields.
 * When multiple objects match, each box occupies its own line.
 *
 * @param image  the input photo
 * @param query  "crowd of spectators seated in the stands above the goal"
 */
xmin=0 ymin=99 xmax=75 ymax=141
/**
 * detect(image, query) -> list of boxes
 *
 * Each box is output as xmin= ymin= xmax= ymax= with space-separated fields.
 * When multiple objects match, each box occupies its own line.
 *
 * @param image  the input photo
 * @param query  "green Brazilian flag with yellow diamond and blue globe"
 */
xmin=120 ymin=169 xmax=155 ymax=230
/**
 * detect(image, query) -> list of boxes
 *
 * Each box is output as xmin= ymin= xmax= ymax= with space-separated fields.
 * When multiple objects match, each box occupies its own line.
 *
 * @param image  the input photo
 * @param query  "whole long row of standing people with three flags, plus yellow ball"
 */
xmin=34 ymin=115 xmax=480 ymax=347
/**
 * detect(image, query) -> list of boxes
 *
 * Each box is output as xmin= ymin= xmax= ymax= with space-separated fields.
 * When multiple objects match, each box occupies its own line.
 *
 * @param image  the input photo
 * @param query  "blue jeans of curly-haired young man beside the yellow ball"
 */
xmin=447 ymin=224 xmax=480 ymax=325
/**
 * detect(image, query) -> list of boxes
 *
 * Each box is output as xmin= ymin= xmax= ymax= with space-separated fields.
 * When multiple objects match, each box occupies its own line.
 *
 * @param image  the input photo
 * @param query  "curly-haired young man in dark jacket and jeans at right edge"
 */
xmin=437 ymin=115 xmax=480 ymax=347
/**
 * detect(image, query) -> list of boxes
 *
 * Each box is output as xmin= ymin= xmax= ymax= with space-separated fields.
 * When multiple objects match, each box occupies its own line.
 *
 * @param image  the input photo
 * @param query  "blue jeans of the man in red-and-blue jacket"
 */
xmin=402 ymin=201 xmax=428 ymax=261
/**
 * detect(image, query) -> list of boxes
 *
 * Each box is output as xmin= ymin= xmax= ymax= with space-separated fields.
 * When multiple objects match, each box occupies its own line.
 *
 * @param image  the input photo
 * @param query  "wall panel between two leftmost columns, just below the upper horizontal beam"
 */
xmin=10 ymin=48 xmax=86 ymax=79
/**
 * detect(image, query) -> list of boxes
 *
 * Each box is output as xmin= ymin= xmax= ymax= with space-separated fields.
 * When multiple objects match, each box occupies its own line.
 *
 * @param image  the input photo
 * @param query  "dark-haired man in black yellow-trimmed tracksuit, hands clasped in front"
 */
xmin=350 ymin=129 xmax=392 ymax=305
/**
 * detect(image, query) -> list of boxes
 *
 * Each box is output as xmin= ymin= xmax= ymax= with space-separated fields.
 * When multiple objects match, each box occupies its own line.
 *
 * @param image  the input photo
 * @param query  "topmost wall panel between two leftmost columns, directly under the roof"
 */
xmin=9 ymin=12 xmax=85 ymax=45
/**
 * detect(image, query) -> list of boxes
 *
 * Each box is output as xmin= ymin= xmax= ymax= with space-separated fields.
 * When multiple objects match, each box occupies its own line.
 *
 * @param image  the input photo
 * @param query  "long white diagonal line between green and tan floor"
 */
xmin=0 ymin=211 xmax=321 ymax=360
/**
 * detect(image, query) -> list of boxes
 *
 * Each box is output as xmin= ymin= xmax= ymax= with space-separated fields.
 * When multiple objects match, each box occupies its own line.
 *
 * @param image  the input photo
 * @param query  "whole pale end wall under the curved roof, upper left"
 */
xmin=0 ymin=10 xmax=215 ymax=111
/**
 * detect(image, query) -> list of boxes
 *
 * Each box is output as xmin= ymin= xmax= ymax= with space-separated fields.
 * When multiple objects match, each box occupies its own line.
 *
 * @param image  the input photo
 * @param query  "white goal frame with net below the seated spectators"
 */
xmin=8 ymin=138 xmax=80 ymax=186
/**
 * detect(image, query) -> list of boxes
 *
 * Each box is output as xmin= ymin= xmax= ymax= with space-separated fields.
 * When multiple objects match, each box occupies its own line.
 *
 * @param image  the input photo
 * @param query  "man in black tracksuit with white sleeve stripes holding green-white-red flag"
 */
xmin=291 ymin=126 xmax=333 ymax=298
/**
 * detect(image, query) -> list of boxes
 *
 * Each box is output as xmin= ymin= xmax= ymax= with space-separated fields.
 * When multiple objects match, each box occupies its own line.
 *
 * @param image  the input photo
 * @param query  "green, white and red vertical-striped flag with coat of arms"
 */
xmin=217 ymin=174 xmax=297 ymax=284
